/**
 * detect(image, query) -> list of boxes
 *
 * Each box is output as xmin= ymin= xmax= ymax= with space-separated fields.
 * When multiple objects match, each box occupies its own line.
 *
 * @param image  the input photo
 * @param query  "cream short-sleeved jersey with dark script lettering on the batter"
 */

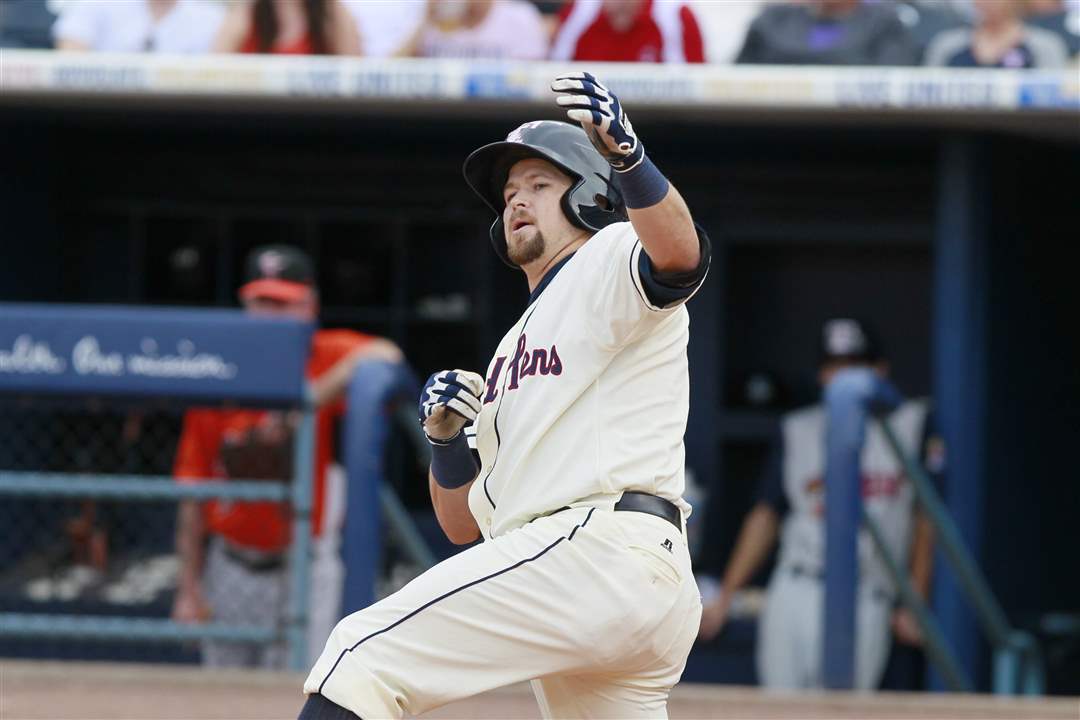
xmin=469 ymin=222 xmax=703 ymax=538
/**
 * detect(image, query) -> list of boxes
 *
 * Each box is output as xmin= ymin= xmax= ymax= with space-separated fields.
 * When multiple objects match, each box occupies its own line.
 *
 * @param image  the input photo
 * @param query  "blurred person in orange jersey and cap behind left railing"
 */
xmin=173 ymin=245 xmax=402 ymax=668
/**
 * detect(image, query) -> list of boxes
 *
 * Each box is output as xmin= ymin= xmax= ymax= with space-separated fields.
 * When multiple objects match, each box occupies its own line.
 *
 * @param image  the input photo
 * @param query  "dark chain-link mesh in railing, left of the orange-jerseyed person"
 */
xmin=0 ymin=397 xmax=190 ymax=661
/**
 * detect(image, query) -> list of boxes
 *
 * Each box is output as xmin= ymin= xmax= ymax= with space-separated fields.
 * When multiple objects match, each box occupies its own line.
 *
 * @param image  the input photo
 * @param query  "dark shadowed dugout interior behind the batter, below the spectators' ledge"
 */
xmin=0 ymin=57 xmax=1080 ymax=692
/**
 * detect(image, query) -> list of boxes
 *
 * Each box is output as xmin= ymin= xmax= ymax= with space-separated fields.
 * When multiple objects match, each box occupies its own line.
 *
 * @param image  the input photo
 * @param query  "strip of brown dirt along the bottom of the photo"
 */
xmin=0 ymin=658 xmax=1080 ymax=720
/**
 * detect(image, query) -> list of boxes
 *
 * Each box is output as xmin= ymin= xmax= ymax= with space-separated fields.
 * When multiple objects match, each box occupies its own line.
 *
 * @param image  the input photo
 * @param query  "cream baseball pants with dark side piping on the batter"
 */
xmin=303 ymin=507 xmax=701 ymax=720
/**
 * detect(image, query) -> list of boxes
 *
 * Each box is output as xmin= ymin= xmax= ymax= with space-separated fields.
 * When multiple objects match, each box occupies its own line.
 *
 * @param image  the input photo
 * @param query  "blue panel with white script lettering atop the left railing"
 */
xmin=0 ymin=303 xmax=313 ymax=405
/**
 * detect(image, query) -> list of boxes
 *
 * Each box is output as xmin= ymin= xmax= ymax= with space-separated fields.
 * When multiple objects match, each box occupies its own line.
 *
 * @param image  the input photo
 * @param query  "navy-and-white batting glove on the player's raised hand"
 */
xmin=551 ymin=72 xmax=645 ymax=173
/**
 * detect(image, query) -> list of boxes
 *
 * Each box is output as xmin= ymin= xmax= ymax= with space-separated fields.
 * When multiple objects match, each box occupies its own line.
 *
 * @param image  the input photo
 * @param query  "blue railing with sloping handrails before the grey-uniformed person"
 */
xmin=823 ymin=368 xmax=1045 ymax=695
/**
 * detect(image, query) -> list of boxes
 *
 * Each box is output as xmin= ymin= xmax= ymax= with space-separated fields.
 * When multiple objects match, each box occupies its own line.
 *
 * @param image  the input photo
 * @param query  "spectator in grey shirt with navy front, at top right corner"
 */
xmin=924 ymin=0 xmax=1068 ymax=69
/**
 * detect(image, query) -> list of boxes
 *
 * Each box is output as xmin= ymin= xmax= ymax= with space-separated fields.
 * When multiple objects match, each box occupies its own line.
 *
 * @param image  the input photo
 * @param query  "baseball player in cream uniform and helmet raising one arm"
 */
xmin=300 ymin=73 xmax=710 ymax=720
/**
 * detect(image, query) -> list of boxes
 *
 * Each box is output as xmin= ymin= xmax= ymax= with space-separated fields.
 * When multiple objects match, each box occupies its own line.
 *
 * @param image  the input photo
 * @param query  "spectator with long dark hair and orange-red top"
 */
xmin=214 ymin=0 xmax=361 ymax=55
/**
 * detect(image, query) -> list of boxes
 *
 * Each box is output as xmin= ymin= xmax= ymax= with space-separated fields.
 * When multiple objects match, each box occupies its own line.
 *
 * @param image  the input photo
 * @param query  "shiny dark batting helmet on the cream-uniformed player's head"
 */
xmin=462 ymin=120 xmax=626 ymax=268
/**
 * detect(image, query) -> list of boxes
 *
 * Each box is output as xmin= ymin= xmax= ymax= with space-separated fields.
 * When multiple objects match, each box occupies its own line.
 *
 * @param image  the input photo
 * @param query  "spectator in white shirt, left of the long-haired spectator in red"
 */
xmin=53 ymin=0 xmax=225 ymax=53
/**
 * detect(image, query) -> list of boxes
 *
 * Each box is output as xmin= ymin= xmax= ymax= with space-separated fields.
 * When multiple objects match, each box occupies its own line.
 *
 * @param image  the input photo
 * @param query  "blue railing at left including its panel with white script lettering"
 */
xmin=0 ymin=304 xmax=314 ymax=669
